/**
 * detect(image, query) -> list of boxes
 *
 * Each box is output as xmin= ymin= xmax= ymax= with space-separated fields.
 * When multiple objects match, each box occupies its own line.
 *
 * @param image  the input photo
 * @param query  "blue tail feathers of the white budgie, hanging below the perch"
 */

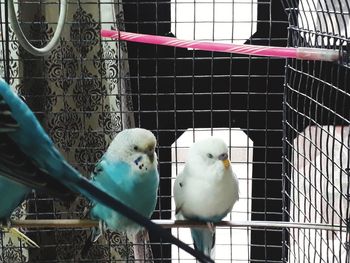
xmin=191 ymin=228 xmax=215 ymax=257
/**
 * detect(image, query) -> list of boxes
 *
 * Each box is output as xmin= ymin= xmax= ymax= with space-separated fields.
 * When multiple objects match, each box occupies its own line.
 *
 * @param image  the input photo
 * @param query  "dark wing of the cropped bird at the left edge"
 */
xmin=0 ymin=95 xmax=72 ymax=197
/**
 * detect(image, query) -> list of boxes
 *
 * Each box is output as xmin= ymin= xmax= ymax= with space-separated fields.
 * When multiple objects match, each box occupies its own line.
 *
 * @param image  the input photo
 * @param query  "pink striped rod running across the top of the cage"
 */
xmin=101 ymin=29 xmax=339 ymax=61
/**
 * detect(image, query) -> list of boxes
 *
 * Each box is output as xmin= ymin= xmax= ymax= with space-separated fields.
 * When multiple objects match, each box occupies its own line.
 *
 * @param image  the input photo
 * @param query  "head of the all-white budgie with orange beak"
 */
xmin=187 ymin=137 xmax=231 ymax=172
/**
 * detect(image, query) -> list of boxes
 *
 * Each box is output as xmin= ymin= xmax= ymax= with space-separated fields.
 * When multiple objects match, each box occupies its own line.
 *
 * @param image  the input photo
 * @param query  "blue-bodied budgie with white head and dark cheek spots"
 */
xmin=82 ymin=128 xmax=159 ymax=255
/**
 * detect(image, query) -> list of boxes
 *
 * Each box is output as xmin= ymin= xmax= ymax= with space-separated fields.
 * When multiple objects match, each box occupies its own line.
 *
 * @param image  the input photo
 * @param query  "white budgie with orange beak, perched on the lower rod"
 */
xmin=174 ymin=137 xmax=239 ymax=256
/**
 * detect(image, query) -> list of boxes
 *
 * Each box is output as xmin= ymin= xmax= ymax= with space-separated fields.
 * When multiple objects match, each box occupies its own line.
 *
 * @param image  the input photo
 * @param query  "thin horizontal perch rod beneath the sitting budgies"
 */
xmin=11 ymin=219 xmax=347 ymax=232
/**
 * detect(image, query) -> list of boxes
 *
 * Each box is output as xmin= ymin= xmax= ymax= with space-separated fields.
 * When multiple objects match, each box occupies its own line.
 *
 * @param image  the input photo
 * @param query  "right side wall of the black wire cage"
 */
xmin=284 ymin=1 xmax=350 ymax=262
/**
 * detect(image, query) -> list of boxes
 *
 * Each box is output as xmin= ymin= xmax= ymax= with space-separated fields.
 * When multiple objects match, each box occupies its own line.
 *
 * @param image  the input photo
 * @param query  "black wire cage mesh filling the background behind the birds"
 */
xmin=0 ymin=0 xmax=350 ymax=263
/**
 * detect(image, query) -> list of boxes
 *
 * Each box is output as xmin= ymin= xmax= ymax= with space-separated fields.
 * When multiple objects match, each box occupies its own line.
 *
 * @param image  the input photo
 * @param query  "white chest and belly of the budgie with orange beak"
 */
xmin=182 ymin=178 xmax=234 ymax=221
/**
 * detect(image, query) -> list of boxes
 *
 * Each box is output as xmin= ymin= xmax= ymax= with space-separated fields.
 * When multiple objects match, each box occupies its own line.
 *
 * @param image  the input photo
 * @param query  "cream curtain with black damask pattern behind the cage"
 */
xmin=0 ymin=0 xmax=134 ymax=262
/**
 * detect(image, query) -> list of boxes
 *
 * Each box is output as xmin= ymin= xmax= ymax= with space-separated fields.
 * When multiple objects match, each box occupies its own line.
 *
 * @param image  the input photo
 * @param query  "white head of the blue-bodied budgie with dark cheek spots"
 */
xmin=107 ymin=128 xmax=157 ymax=165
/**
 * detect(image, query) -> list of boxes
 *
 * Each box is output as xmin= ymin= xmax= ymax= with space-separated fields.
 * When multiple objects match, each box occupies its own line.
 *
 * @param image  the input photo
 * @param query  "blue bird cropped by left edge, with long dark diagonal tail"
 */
xmin=0 ymin=79 xmax=212 ymax=262
